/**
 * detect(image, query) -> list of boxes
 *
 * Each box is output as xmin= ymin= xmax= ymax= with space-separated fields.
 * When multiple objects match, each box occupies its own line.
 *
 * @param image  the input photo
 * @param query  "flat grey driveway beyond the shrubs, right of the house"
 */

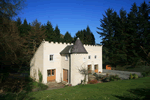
xmin=103 ymin=69 xmax=142 ymax=79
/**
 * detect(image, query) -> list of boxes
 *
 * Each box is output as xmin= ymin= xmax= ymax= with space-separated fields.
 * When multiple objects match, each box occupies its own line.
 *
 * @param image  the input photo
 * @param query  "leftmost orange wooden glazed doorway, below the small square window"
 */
xmin=47 ymin=69 xmax=56 ymax=82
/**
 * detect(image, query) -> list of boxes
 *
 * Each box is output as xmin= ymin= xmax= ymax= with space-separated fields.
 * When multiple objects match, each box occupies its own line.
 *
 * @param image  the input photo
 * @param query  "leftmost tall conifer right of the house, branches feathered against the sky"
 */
xmin=97 ymin=8 xmax=118 ymax=64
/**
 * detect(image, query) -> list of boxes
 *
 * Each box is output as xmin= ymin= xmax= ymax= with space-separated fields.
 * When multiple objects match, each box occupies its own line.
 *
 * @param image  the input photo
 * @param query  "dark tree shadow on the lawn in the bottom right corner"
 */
xmin=113 ymin=88 xmax=150 ymax=100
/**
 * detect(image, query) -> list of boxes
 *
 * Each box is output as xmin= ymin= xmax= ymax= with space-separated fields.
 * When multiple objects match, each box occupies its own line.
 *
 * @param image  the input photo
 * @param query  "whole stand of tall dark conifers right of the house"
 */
xmin=97 ymin=1 xmax=150 ymax=66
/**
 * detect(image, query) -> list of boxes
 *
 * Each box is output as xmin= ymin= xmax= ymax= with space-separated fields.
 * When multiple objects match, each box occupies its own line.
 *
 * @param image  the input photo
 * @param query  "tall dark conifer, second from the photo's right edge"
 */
xmin=127 ymin=3 xmax=141 ymax=66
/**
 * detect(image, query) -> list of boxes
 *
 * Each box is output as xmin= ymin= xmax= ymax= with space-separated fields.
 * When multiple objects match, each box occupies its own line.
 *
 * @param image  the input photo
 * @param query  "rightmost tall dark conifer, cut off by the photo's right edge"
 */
xmin=138 ymin=1 xmax=150 ymax=65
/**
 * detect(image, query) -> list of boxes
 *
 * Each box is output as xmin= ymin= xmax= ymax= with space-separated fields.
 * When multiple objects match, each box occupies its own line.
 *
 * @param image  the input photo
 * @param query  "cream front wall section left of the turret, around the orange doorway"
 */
xmin=43 ymin=41 xmax=70 ymax=83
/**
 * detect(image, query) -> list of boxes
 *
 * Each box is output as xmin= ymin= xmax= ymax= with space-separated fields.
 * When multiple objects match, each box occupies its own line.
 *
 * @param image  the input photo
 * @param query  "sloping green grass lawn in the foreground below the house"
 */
xmin=14 ymin=77 xmax=150 ymax=100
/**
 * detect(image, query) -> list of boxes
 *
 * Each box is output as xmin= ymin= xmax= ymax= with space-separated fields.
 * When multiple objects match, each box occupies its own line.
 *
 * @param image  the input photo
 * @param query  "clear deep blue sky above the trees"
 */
xmin=16 ymin=0 xmax=150 ymax=43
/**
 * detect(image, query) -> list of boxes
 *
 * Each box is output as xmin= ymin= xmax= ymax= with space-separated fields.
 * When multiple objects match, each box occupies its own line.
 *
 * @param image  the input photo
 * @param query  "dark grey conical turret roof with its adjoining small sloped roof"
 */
xmin=60 ymin=38 xmax=88 ymax=54
